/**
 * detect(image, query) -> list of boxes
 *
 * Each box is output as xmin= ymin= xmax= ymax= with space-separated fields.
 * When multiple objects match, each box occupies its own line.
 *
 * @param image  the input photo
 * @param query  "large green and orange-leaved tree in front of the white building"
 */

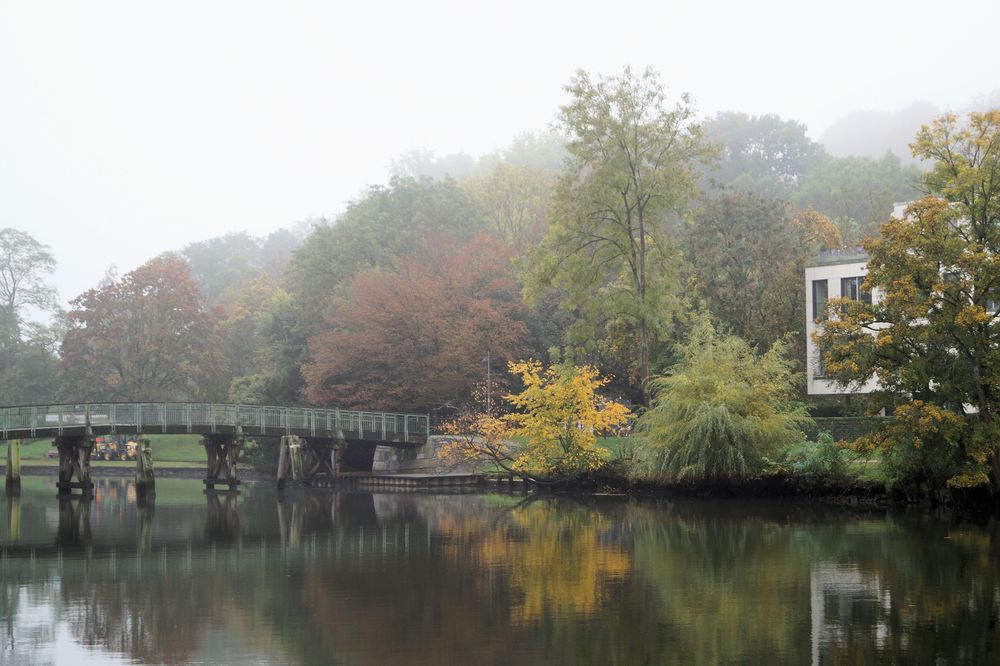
xmin=817 ymin=110 xmax=1000 ymax=490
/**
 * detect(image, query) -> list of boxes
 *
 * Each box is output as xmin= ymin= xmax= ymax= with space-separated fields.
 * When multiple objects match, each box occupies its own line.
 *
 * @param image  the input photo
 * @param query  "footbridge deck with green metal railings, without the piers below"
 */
xmin=0 ymin=402 xmax=429 ymax=446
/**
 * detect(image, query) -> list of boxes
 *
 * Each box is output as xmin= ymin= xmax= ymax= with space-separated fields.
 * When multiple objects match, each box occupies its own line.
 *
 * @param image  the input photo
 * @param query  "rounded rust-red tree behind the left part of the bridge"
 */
xmin=60 ymin=255 xmax=218 ymax=402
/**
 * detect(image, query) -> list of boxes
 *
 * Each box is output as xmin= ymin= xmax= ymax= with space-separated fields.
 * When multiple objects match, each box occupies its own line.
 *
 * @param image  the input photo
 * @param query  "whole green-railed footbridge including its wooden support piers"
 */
xmin=0 ymin=402 xmax=430 ymax=492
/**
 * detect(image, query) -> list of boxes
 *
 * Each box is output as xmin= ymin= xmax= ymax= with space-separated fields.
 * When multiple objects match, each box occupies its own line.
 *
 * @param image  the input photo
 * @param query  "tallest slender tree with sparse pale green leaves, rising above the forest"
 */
xmin=526 ymin=68 xmax=707 ymax=403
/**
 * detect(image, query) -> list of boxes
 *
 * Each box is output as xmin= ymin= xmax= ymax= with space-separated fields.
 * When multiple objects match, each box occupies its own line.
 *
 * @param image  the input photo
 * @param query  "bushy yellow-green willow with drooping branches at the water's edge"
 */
xmin=639 ymin=314 xmax=809 ymax=482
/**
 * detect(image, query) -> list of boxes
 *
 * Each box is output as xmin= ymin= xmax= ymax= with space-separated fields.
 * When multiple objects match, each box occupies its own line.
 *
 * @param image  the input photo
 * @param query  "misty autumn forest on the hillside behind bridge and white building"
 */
xmin=0 ymin=66 xmax=921 ymax=415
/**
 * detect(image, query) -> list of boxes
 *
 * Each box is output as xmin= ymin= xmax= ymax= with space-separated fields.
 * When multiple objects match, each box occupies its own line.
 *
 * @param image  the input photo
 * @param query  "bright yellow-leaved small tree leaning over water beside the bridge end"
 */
xmin=438 ymin=361 xmax=631 ymax=483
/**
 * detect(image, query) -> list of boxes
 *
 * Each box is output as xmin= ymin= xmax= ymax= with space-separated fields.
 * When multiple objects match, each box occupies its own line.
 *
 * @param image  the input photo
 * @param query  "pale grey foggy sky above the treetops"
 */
xmin=0 ymin=0 xmax=1000 ymax=312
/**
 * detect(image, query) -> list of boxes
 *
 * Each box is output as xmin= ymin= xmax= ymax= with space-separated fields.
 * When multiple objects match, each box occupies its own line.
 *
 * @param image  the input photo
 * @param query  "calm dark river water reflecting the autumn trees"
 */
xmin=0 ymin=478 xmax=1000 ymax=666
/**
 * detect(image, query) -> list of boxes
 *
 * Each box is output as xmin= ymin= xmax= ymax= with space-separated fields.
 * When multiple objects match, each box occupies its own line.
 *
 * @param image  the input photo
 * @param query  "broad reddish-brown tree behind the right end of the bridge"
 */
xmin=303 ymin=234 xmax=528 ymax=410
